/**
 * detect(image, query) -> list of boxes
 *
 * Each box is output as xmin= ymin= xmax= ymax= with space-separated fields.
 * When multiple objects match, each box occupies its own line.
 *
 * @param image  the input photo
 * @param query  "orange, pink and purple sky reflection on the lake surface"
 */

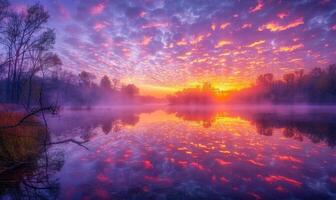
xmin=45 ymin=108 xmax=336 ymax=198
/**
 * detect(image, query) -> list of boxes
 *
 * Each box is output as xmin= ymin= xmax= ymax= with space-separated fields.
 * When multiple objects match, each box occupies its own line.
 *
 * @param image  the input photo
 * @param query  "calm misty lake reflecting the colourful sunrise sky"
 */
xmin=0 ymin=106 xmax=336 ymax=200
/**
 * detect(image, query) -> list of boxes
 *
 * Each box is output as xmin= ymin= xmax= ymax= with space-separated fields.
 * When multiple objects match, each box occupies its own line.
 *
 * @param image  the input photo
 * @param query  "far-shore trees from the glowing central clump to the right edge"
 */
xmin=168 ymin=64 xmax=336 ymax=105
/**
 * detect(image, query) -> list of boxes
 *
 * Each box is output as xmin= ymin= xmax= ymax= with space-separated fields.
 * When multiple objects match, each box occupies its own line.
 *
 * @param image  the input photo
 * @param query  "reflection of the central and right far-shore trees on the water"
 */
xmin=168 ymin=107 xmax=336 ymax=147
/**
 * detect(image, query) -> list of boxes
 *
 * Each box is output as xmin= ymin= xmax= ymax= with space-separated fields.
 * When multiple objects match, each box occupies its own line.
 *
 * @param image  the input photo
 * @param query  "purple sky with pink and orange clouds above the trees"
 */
xmin=11 ymin=0 xmax=336 ymax=96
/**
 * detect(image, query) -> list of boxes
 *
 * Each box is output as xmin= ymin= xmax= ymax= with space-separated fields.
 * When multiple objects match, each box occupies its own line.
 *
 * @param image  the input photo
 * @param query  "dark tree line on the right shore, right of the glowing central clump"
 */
xmin=229 ymin=64 xmax=336 ymax=104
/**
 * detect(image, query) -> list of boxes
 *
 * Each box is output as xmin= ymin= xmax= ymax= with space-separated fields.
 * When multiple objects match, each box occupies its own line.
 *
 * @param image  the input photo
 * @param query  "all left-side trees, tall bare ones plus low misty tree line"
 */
xmin=0 ymin=0 xmax=155 ymax=109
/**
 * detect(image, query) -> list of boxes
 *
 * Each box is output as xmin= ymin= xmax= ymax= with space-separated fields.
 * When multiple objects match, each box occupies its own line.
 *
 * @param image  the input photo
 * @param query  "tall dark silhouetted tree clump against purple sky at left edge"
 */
xmin=0 ymin=0 xmax=61 ymax=107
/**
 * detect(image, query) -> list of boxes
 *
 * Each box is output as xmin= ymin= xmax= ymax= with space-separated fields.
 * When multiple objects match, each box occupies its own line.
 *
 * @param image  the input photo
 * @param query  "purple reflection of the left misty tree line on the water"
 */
xmin=48 ymin=107 xmax=156 ymax=140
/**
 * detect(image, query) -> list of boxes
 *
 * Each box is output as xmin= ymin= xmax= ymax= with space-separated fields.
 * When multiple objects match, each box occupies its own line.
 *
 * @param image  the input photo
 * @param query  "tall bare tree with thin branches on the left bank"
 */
xmin=0 ymin=4 xmax=59 ymax=106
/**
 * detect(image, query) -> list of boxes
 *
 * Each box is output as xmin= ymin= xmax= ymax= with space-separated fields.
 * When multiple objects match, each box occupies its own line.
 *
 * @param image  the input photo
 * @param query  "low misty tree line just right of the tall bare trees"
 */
xmin=52 ymin=71 xmax=145 ymax=107
